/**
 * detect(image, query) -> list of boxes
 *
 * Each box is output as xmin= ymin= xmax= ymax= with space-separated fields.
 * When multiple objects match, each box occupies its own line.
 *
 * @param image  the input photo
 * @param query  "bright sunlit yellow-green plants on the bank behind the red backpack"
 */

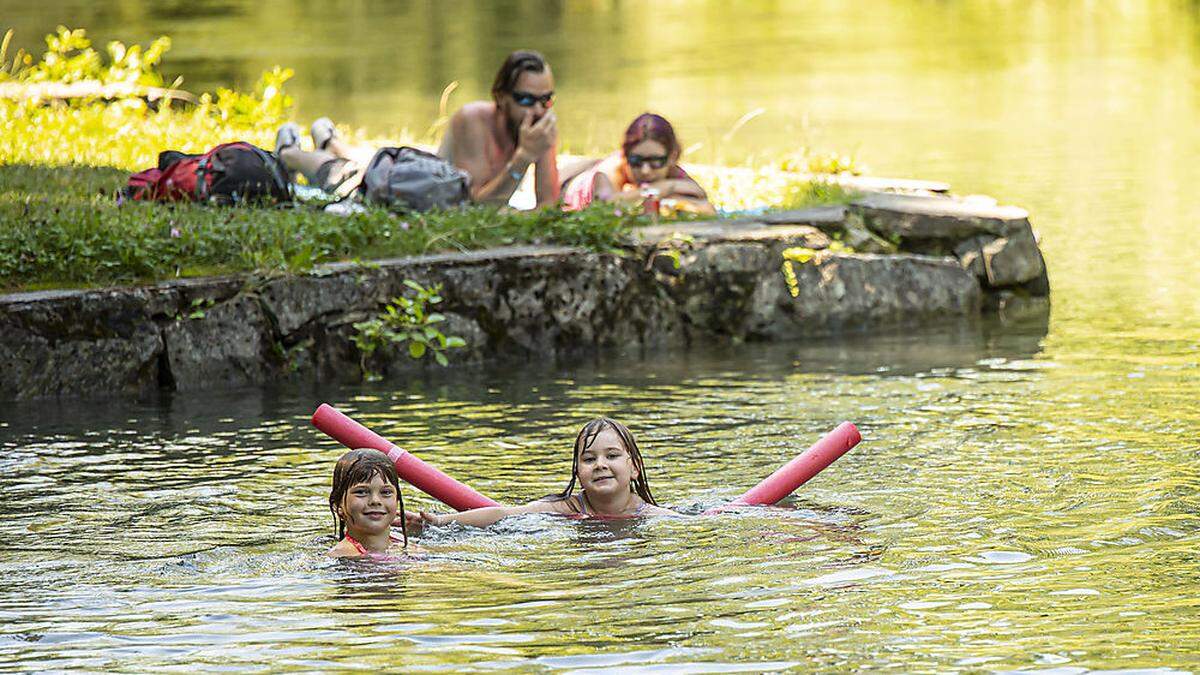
xmin=0 ymin=26 xmax=292 ymax=171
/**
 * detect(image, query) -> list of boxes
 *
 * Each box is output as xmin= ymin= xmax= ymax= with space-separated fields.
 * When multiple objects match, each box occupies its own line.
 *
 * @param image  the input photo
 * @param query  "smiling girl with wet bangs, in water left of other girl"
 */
xmin=326 ymin=449 xmax=408 ymax=557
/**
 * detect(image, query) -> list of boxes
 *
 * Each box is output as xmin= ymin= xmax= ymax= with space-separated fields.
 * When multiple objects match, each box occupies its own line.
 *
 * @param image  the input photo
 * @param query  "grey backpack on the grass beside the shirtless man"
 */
xmin=360 ymin=145 xmax=470 ymax=211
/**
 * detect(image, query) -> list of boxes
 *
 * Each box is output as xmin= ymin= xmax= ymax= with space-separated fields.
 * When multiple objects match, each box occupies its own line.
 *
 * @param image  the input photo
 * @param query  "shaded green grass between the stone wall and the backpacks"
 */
xmin=0 ymin=165 xmax=635 ymax=291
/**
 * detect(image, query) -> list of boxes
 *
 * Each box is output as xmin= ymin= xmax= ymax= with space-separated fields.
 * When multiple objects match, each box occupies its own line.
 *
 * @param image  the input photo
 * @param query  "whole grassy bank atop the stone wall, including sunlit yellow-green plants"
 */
xmin=0 ymin=29 xmax=846 ymax=291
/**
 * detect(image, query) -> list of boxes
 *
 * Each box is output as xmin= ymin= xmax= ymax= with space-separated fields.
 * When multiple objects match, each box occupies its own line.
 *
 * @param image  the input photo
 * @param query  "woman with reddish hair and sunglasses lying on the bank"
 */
xmin=563 ymin=113 xmax=716 ymax=215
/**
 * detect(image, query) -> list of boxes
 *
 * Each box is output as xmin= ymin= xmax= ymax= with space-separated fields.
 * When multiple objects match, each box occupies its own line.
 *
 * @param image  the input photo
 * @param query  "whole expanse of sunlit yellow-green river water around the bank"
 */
xmin=0 ymin=0 xmax=1200 ymax=673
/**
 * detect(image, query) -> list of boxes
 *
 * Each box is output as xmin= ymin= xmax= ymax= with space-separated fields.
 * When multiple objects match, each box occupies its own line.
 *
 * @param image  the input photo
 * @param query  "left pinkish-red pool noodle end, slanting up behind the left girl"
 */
xmin=312 ymin=404 xmax=500 ymax=510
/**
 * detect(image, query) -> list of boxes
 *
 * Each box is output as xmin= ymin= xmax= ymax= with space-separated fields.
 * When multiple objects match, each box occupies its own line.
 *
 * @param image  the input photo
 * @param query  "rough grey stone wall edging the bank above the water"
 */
xmin=0 ymin=189 xmax=1049 ymax=400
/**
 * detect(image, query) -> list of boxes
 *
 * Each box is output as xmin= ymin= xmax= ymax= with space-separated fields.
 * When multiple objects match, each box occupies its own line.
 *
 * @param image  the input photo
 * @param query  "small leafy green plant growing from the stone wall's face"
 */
xmin=350 ymin=279 xmax=467 ymax=378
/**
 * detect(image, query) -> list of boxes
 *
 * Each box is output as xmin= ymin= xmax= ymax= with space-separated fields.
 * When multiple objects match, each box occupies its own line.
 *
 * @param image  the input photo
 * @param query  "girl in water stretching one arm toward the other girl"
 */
xmin=407 ymin=417 xmax=678 ymax=527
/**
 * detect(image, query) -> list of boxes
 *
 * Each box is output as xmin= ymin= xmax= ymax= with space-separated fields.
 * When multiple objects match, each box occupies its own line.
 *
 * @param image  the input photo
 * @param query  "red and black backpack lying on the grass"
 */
xmin=121 ymin=142 xmax=292 ymax=204
